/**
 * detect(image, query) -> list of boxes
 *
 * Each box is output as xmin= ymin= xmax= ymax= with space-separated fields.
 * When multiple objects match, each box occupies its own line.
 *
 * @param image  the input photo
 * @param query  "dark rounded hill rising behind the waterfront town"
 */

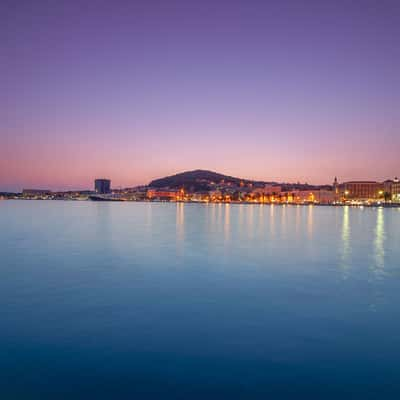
xmin=149 ymin=169 xmax=264 ymax=191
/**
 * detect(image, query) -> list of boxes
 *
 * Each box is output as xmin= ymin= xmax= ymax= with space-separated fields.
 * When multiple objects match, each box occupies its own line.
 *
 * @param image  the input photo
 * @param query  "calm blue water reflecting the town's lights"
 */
xmin=0 ymin=201 xmax=400 ymax=400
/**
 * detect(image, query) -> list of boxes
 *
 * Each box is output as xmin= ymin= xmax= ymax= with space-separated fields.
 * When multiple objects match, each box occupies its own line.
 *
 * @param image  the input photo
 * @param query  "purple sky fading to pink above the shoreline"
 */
xmin=0 ymin=0 xmax=400 ymax=191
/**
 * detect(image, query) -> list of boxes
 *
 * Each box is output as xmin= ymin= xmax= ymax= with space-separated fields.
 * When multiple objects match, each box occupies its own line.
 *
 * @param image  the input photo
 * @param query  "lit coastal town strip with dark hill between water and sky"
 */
xmin=0 ymin=170 xmax=400 ymax=207
